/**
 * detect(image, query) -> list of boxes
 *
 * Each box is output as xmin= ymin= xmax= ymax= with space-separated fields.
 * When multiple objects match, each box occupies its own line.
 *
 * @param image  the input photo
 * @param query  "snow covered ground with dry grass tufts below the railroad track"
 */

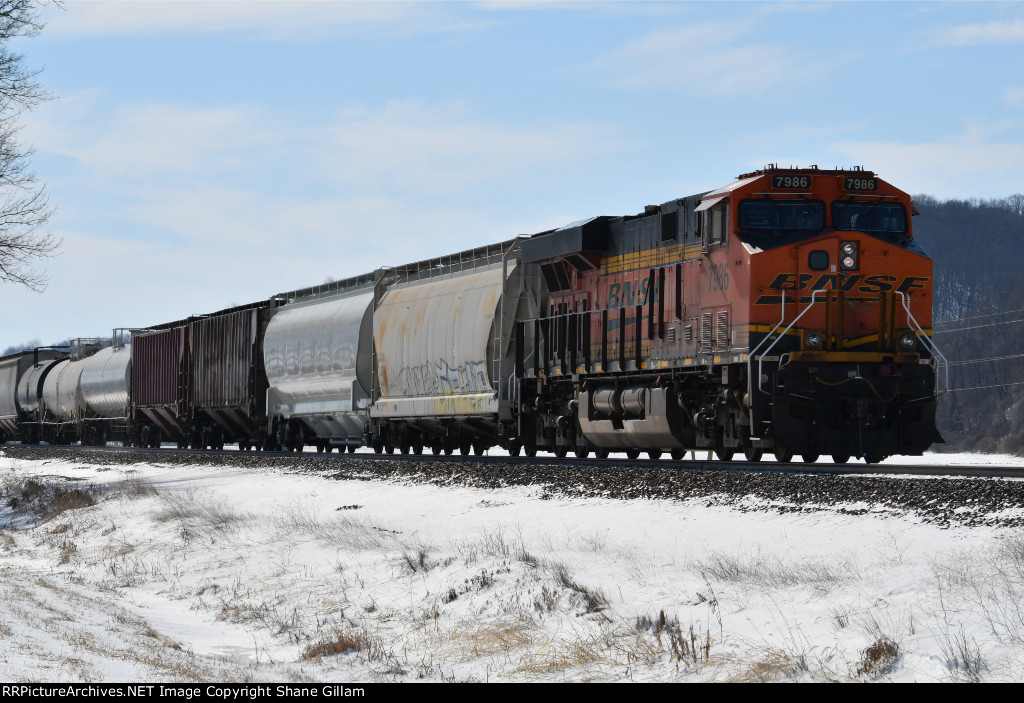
xmin=0 ymin=450 xmax=1024 ymax=682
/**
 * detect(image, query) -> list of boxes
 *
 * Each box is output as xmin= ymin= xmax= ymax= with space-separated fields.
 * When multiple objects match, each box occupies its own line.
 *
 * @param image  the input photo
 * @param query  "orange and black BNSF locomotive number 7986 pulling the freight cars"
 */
xmin=511 ymin=167 xmax=945 ymax=463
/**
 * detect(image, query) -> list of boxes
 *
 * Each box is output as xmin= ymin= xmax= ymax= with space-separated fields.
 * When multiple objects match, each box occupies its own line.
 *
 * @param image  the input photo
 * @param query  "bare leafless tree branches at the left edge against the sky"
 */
xmin=0 ymin=0 xmax=61 ymax=291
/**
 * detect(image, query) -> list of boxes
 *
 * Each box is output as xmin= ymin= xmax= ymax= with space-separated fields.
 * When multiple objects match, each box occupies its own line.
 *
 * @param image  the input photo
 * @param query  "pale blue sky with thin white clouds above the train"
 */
xmin=0 ymin=0 xmax=1024 ymax=347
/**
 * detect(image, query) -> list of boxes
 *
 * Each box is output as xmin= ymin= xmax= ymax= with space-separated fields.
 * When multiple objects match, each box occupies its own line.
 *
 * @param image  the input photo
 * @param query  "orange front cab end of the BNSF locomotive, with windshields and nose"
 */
xmin=735 ymin=164 xmax=944 ymax=462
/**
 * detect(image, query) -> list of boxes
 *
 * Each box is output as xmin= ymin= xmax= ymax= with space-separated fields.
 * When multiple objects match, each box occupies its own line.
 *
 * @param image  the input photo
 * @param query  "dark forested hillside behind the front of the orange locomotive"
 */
xmin=913 ymin=194 xmax=1024 ymax=454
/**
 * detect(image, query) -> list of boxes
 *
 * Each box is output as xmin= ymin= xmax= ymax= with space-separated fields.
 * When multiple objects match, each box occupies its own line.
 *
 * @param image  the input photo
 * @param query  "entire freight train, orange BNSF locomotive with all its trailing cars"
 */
xmin=0 ymin=166 xmax=946 ymax=463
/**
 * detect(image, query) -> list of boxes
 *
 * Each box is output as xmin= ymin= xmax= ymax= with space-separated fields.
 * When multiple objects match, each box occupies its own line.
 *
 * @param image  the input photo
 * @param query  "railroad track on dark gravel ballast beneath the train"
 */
xmin=3 ymin=445 xmax=1024 ymax=529
